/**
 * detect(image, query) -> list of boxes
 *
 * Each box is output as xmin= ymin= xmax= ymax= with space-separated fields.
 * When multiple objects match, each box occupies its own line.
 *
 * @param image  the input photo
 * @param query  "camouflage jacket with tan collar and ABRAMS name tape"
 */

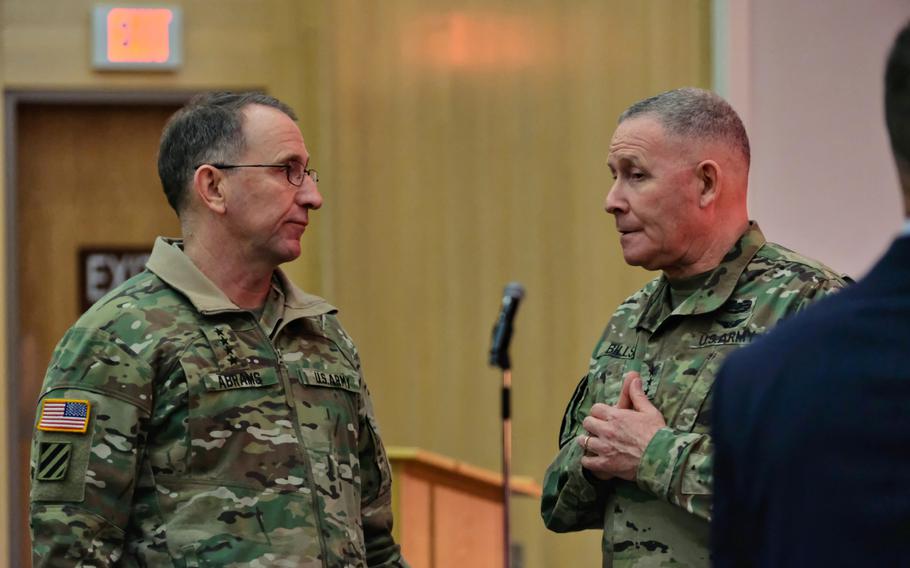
xmin=30 ymin=239 xmax=405 ymax=568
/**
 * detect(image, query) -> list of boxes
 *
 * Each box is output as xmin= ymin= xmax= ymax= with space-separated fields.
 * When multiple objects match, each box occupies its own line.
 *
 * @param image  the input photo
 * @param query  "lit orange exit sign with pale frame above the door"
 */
xmin=92 ymin=4 xmax=183 ymax=71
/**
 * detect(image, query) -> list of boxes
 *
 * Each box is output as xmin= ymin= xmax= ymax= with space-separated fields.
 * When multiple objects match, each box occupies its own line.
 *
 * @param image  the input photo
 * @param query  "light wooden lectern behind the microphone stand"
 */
xmin=388 ymin=447 xmax=541 ymax=568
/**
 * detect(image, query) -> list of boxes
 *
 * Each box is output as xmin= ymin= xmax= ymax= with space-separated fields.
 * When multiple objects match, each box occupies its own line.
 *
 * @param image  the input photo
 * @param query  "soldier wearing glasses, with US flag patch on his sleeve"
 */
xmin=31 ymin=93 xmax=405 ymax=568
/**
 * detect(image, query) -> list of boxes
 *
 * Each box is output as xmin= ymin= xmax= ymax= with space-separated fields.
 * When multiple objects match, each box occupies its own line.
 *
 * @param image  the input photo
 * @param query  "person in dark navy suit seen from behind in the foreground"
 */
xmin=712 ymin=20 xmax=910 ymax=568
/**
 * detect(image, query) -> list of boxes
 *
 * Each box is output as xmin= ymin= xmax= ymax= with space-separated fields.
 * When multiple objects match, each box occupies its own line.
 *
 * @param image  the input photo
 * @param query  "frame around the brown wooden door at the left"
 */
xmin=0 ymin=89 xmax=203 ymax=566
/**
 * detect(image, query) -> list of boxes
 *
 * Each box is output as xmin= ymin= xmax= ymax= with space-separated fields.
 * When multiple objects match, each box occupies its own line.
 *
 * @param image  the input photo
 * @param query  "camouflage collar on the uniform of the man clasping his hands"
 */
xmin=635 ymin=221 xmax=766 ymax=333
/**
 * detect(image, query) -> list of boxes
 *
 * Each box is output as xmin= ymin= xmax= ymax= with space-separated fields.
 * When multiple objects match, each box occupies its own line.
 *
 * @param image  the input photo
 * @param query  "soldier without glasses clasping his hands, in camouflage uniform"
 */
xmin=541 ymin=89 xmax=845 ymax=567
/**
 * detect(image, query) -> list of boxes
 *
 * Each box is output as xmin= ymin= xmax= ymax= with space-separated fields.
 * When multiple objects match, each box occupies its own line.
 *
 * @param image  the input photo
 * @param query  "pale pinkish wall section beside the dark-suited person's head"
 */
xmin=715 ymin=0 xmax=910 ymax=277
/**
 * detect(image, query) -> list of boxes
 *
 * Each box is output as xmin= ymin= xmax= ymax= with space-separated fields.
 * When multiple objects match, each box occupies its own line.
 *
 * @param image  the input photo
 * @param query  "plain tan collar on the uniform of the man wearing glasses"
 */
xmin=146 ymin=237 xmax=338 ymax=322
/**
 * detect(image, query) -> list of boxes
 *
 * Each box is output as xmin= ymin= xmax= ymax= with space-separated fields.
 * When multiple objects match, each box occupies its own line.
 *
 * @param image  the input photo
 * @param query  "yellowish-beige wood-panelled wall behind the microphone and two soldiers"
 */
xmin=0 ymin=0 xmax=710 ymax=568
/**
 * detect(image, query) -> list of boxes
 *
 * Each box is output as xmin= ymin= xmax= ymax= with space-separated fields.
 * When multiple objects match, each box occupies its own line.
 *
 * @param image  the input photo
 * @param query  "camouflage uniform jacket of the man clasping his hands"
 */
xmin=541 ymin=223 xmax=845 ymax=566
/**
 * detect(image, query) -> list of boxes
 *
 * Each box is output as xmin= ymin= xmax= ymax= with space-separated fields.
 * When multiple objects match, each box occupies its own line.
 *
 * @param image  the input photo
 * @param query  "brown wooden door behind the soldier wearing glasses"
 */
xmin=11 ymin=104 xmax=180 ymax=566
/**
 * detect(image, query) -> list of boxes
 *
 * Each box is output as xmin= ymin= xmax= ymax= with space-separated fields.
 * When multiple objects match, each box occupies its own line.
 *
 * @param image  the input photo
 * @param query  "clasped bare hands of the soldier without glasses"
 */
xmin=577 ymin=372 xmax=667 ymax=481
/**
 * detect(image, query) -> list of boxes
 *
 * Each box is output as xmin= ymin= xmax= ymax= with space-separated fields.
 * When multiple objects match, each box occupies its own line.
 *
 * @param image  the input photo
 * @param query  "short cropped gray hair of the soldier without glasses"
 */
xmin=619 ymin=87 xmax=752 ymax=166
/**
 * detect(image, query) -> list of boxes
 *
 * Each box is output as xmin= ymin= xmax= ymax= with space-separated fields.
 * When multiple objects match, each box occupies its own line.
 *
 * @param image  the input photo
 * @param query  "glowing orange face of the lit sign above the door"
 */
xmin=107 ymin=8 xmax=174 ymax=63
